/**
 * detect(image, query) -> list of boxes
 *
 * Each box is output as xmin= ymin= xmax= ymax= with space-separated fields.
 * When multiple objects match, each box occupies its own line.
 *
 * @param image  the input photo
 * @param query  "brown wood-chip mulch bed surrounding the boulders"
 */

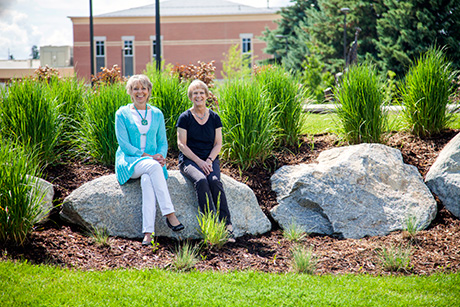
xmin=0 ymin=130 xmax=460 ymax=274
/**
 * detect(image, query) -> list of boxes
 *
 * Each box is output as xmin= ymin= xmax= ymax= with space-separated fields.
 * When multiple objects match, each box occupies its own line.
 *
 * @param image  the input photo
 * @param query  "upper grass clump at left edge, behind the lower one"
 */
xmin=0 ymin=79 xmax=64 ymax=166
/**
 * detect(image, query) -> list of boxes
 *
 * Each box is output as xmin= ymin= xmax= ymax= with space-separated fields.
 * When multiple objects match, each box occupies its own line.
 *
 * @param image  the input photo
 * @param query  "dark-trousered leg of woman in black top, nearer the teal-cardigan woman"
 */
xmin=179 ymin=159 xmax=215 ymax=213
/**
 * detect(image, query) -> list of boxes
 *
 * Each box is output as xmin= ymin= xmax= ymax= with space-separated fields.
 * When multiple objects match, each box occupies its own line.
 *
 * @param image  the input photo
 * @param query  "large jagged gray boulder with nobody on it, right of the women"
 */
xmin=271 ymin=144 xmax=437 ymax=239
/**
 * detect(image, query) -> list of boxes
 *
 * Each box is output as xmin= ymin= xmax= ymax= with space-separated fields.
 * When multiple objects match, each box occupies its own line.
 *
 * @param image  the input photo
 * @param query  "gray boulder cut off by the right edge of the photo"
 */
xmin=425 ymin=133 xmax=460 ymax=218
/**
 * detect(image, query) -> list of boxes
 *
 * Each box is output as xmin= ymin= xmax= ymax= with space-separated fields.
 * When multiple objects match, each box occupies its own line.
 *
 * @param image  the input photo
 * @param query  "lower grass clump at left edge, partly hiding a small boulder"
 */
xmin=0 ymin=138 xmax=47 ymax=245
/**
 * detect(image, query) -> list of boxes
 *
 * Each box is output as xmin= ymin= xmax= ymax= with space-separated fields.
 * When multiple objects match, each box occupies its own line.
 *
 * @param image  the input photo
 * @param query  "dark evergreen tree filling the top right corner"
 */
xmin=376 ymin=0 xmax=460 ymax=76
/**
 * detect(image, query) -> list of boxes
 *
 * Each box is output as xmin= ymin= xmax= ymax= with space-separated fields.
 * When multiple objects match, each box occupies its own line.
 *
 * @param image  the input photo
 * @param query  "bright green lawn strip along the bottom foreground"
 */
xmin=0 ymin=261 xmax=460 ymax=306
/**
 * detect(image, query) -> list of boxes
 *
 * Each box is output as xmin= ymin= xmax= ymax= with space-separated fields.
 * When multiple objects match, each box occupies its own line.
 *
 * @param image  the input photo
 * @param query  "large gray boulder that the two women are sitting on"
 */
xmin=61 ymin=170 xmax=271 ymax=239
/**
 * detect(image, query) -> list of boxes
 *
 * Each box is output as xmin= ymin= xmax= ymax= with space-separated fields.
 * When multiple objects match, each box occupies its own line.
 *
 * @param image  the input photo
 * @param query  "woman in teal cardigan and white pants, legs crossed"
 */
xmin=115 ymin=75 xmax=184 ymax=245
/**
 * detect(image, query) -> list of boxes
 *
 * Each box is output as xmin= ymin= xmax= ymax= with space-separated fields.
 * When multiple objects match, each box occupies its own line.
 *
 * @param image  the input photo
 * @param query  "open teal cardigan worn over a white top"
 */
xmin=115 ymin=104 xmax=168 ymax=184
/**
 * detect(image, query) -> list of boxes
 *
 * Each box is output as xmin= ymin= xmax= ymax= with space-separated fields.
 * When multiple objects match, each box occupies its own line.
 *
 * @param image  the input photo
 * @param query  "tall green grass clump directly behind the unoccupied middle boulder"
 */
xmin=334 ymin=64 xmax=387 ymax=144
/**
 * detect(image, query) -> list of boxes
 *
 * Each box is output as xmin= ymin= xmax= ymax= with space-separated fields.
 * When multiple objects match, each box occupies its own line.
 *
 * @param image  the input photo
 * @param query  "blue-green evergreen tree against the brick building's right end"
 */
xmin=261 ymin=0 xmax=317 ymax=70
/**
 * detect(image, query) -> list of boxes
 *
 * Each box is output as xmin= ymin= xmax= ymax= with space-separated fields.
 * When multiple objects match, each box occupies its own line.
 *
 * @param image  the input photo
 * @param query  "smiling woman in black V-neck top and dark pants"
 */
xmin=177 ymin=80 xmax=235 ymax=242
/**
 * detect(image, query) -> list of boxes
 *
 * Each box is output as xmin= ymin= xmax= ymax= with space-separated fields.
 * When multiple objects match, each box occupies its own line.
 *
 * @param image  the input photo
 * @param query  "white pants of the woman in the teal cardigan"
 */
xmin=131 ymin=159 xmax=174 ymax=233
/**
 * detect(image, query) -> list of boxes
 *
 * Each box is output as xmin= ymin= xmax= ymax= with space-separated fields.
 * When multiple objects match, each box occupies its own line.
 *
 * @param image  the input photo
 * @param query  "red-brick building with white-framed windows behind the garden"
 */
xmin=70 ymin=0 xmax=280 ymax=80
